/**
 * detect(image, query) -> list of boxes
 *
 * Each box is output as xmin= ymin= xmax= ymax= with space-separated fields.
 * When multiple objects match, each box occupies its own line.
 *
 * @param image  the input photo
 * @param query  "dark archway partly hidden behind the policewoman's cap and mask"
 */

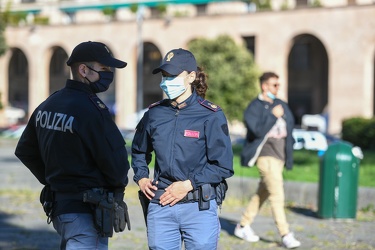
xmin=142 ymin=42 xmax=163 ymax=108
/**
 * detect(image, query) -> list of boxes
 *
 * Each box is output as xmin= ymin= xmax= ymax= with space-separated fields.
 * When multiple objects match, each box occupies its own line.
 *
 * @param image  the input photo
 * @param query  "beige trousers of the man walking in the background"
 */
xmin=240 ymin=156 xmax=289 ymax=236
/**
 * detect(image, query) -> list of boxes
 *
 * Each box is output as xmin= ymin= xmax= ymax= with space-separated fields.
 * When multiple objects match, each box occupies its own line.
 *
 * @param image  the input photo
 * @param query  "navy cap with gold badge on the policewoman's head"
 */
xmin=152 ymin=48 xmax=197 ymax=75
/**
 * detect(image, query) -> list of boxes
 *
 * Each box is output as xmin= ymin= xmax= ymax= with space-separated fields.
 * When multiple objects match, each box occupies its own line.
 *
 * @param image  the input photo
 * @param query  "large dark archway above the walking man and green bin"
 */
xmin=288 ymin=34 xmax=329 ymax=125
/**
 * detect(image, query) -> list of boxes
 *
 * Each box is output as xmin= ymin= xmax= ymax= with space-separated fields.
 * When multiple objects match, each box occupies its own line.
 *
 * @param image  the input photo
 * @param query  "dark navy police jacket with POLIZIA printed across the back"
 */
xmin=15 ymin=80 xmax=130 ymax=215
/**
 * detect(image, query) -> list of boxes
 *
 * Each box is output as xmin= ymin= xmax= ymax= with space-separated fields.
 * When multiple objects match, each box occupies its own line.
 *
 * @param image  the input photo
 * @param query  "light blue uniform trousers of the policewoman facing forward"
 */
xmin=147 ymin=200 xmax=221 ymax=250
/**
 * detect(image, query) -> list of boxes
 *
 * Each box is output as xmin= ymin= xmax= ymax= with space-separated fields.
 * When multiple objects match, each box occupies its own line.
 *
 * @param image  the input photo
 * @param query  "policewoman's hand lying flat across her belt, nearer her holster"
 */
xmin=160 ymin=180 xmax=193 ymax=206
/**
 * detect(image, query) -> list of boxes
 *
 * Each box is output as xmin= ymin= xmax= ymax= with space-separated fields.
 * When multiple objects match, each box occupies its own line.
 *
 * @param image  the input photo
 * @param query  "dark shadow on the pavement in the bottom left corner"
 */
xmin=0 ymin=212 xmax=60 ymax=250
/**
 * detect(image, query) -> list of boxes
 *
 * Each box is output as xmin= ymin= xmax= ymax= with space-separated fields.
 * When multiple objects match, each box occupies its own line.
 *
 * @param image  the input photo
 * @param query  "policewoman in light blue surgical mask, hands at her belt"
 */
xmin=132 ymin=49 xmax=234 ymax=249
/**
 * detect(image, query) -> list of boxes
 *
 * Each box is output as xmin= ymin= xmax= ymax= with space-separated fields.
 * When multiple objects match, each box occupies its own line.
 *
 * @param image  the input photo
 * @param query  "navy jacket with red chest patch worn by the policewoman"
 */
xmin=132 ymin=92 xmax=234 ymax=189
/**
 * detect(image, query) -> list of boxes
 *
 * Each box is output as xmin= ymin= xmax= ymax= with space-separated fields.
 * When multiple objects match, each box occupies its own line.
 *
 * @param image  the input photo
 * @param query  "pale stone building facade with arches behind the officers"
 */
xmin=0 ymin=4 xmax=375 ymax=136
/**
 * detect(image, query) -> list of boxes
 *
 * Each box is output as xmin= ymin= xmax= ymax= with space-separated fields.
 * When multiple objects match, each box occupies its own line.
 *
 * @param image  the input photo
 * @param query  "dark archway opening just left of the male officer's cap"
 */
xmin=49 ymin=46 xmax=70 ymax=94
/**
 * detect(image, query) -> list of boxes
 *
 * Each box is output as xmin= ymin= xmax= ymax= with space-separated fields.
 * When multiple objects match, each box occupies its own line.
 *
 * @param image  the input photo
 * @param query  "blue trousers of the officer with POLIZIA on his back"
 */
xmin=52 ymin=213 xmax=108 ymax=250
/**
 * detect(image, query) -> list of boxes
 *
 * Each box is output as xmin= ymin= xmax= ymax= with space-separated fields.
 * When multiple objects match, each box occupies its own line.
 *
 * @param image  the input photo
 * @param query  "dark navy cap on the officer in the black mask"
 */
xmin=66 ymin=41 xmax=127 ymax=68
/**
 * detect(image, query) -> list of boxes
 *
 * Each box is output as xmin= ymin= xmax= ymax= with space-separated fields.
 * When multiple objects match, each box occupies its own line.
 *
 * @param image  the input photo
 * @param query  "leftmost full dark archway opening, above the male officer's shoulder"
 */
xmin=8 ymin=48 xmax=29 ymax=121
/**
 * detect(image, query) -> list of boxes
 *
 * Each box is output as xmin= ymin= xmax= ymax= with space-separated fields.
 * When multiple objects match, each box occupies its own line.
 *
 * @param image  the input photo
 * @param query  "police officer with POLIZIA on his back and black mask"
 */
xmin=15 ymin=41 xmax=130 ymax=249
